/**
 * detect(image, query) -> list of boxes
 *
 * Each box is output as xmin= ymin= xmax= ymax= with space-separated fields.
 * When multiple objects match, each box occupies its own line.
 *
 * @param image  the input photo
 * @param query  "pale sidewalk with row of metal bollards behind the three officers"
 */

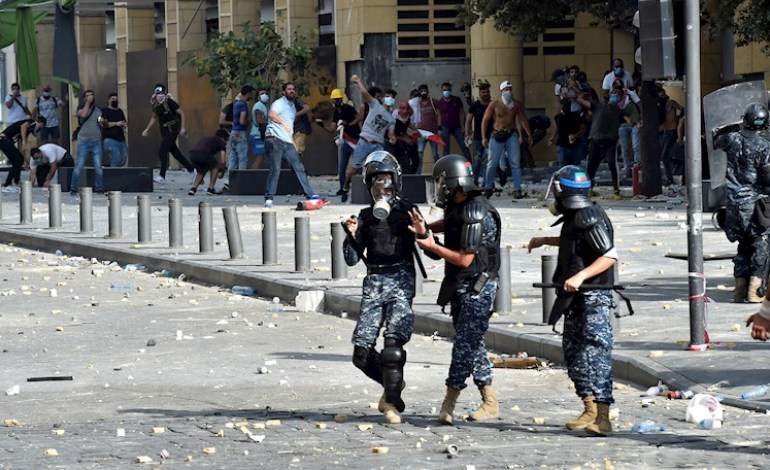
xmin=0 ymin=172 xmax=770 ymax=409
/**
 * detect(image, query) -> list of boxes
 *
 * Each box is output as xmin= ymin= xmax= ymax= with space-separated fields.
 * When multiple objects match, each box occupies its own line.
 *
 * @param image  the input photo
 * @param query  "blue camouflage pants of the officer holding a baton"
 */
xmin=562 ymin=290 xmax=614 ymax=403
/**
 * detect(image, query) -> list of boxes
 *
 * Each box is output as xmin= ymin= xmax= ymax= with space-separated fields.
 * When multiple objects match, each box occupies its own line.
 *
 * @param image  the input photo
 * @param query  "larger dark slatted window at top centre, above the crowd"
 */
xmin=397 ymin=0 xmax=470 ymax=60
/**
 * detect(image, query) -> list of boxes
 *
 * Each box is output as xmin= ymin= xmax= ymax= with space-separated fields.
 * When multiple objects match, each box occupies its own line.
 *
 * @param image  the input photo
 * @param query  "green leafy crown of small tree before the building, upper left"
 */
xmin=189 ymin=23 xmax=313 ymax=96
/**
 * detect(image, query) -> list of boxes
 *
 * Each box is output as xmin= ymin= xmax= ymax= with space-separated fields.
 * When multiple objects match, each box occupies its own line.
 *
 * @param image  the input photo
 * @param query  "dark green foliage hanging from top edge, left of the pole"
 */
xmin=459 ymin=0 xmax=638 ymax=41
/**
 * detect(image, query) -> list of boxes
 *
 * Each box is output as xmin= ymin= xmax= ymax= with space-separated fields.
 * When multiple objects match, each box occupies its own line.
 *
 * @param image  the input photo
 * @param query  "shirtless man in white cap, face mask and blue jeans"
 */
xmin=481 ymin=80 xmax=532 ymax=199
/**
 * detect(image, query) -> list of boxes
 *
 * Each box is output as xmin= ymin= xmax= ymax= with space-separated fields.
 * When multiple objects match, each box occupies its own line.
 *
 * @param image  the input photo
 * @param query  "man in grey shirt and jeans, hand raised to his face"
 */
xmin=70 ymin=90 xmax=104 ymax=196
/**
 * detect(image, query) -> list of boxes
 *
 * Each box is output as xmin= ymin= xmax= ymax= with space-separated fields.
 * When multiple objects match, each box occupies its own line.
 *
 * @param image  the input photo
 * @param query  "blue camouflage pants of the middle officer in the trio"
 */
xmin=446 ymin=280 xmax=497 ymax=390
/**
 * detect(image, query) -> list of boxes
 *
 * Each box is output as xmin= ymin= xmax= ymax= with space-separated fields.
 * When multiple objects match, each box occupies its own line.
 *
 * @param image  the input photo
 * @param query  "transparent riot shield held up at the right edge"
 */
xmin=703 ymin=81 xmax=767 ymax=188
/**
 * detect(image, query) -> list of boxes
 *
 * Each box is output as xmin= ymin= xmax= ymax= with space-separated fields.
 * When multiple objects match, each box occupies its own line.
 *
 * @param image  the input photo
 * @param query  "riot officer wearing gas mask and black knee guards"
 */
xmin=344 ymin=151 xmax=417 ymax=424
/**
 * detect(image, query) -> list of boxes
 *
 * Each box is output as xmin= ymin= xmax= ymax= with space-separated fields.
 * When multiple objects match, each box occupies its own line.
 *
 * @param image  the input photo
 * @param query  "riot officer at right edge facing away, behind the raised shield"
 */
xmin=715 ymin=103 xmax=770 ymax=303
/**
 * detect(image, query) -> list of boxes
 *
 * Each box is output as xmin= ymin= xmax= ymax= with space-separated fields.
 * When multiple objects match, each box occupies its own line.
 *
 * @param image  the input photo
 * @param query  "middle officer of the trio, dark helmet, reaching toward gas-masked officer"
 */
xmin=411 ymin=155 xmax=502 ymax=424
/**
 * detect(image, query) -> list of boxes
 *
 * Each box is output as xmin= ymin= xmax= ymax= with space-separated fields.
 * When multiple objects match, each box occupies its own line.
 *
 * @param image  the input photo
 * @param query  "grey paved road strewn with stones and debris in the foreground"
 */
xmin=0 ymin=245 xmax=770 ymax=469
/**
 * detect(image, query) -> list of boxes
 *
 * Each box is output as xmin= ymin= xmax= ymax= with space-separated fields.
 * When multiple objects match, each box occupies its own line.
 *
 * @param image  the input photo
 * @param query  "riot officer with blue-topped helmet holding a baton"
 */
xmin=529 ymin=165 xmax=617 ymax=435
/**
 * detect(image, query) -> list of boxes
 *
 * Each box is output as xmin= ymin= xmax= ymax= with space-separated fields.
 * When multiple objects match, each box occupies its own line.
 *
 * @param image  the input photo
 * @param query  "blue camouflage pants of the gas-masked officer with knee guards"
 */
xmin=353 ymin=268 xmax=414 ymax=348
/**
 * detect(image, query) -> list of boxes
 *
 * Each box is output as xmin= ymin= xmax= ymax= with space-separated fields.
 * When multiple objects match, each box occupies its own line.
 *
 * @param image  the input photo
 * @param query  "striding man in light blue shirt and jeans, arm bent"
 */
xmin=265 ymin=82 xmax=319 ymax=207
